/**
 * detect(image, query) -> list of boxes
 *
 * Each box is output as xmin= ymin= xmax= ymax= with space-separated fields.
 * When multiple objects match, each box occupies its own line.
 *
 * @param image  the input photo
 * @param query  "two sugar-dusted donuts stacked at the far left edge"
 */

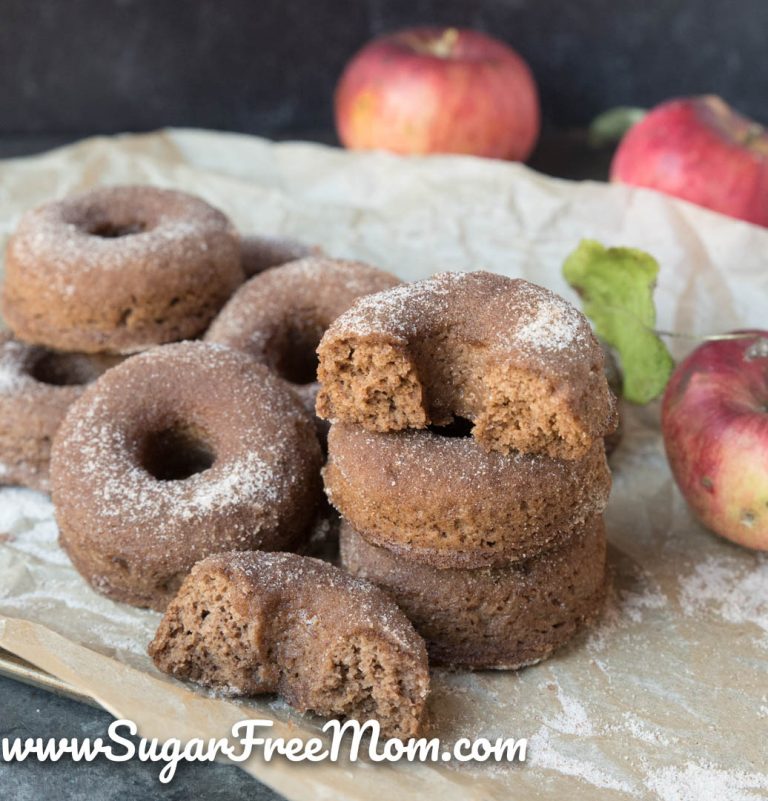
xmin=0 ymin=186 xmax=244 ymax=490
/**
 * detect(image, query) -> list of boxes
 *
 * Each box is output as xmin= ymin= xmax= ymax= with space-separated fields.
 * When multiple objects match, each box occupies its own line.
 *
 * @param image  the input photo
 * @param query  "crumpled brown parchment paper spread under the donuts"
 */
xmin=0 ymin=130 xmax=768 ymax=801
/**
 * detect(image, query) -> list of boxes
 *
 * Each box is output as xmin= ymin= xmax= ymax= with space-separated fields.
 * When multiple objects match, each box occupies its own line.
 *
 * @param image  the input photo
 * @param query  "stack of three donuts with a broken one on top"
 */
xmin=317 ymin=272 xmax=616 ymax=668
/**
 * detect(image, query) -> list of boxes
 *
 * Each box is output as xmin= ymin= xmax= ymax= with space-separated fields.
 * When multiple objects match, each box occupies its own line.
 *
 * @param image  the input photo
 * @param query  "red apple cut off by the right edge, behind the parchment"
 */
xmin=611 ymin=95 xmax=768 ymax=225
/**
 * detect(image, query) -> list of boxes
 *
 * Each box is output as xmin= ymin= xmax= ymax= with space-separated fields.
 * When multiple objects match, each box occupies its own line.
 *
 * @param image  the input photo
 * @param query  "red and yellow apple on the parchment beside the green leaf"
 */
xmin=661 ymin=331 xmax=768 ymax=550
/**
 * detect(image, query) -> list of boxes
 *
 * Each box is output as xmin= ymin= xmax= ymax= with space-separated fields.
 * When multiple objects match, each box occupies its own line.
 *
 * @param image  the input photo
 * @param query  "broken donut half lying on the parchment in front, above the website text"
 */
xmin=149 ymin=553 xmax=429 ymax=738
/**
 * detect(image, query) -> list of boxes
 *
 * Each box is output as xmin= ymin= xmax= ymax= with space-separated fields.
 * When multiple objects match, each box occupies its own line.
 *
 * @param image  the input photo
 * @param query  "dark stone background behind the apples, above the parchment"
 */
xmin=0 ymin=0 xmax=768 ymax=141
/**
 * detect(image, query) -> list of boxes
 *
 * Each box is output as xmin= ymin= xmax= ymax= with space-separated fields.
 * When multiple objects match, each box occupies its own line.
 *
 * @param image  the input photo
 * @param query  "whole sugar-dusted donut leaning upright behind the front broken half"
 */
xmin=51 ymin=342 xmax=321 ymax=610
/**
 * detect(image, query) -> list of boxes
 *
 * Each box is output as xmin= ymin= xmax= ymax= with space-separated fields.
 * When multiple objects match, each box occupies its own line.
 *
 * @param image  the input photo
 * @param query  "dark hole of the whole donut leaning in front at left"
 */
xmin=140 ymin=426 xmax=216 ymax=481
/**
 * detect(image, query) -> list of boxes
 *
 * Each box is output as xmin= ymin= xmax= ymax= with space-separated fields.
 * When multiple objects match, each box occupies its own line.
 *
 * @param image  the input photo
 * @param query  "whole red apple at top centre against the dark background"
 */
xmin=335 ymin=28 xmax=539 ymax=160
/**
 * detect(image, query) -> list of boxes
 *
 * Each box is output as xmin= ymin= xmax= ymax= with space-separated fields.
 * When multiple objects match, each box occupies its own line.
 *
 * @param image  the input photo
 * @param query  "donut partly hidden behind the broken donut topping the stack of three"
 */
xmin=205 ymin=257 xmax=400 ymax=414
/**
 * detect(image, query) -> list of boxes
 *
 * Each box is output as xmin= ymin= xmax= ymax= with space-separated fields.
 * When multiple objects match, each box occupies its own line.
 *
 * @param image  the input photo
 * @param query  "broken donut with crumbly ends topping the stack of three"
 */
xmin=317 ymin=272 xmax=616 ymax=459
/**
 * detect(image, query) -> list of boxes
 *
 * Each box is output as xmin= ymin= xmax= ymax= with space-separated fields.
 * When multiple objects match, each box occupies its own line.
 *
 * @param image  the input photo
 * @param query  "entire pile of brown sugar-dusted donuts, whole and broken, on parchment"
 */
xmin=0 ymin=186 xmax=616 ymax=736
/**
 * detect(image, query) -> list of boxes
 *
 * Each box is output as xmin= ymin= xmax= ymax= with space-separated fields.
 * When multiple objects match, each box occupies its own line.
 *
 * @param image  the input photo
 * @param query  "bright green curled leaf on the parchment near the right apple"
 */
xmin=563 ymin=239 xmax=675 ymax=403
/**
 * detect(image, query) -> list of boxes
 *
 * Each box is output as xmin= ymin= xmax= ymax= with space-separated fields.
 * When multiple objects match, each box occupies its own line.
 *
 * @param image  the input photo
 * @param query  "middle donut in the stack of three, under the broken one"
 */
xmin=323 ymin=423 xmax=611 ymax=568
